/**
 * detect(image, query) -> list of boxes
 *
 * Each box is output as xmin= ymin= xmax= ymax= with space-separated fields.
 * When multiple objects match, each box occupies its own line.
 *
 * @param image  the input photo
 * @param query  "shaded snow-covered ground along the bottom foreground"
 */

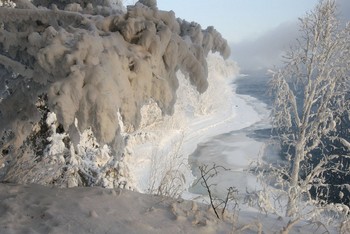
xmin=0 ymin=184 xmax=336 ymax=234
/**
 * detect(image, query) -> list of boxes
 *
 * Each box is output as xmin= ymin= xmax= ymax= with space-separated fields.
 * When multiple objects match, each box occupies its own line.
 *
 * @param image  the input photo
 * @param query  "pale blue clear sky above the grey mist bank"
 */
xmin=158 ymin=0 xmax=318 ymax=43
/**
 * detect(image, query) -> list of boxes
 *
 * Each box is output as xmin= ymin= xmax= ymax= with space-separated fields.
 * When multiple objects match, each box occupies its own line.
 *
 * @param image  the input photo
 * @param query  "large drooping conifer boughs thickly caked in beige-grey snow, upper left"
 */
xmin=0 ymin=1 xmax=229 ymax=146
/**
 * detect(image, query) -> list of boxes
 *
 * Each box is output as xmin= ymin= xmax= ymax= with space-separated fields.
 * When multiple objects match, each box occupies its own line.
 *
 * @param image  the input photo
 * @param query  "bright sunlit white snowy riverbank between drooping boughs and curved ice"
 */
xmin=124 ymin=54 xmax=247 ymax=192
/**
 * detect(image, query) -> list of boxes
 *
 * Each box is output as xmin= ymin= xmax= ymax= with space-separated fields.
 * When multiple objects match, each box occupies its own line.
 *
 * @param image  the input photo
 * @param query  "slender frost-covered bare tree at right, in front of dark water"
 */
xmin=270 ymin=0 xmax=350 ymax=216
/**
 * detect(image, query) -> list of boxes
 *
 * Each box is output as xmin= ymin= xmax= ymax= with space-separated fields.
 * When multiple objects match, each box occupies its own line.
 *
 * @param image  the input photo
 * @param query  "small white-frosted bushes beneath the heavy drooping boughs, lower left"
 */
xmin=3 ymin=101 xmax=125 ymax=187
